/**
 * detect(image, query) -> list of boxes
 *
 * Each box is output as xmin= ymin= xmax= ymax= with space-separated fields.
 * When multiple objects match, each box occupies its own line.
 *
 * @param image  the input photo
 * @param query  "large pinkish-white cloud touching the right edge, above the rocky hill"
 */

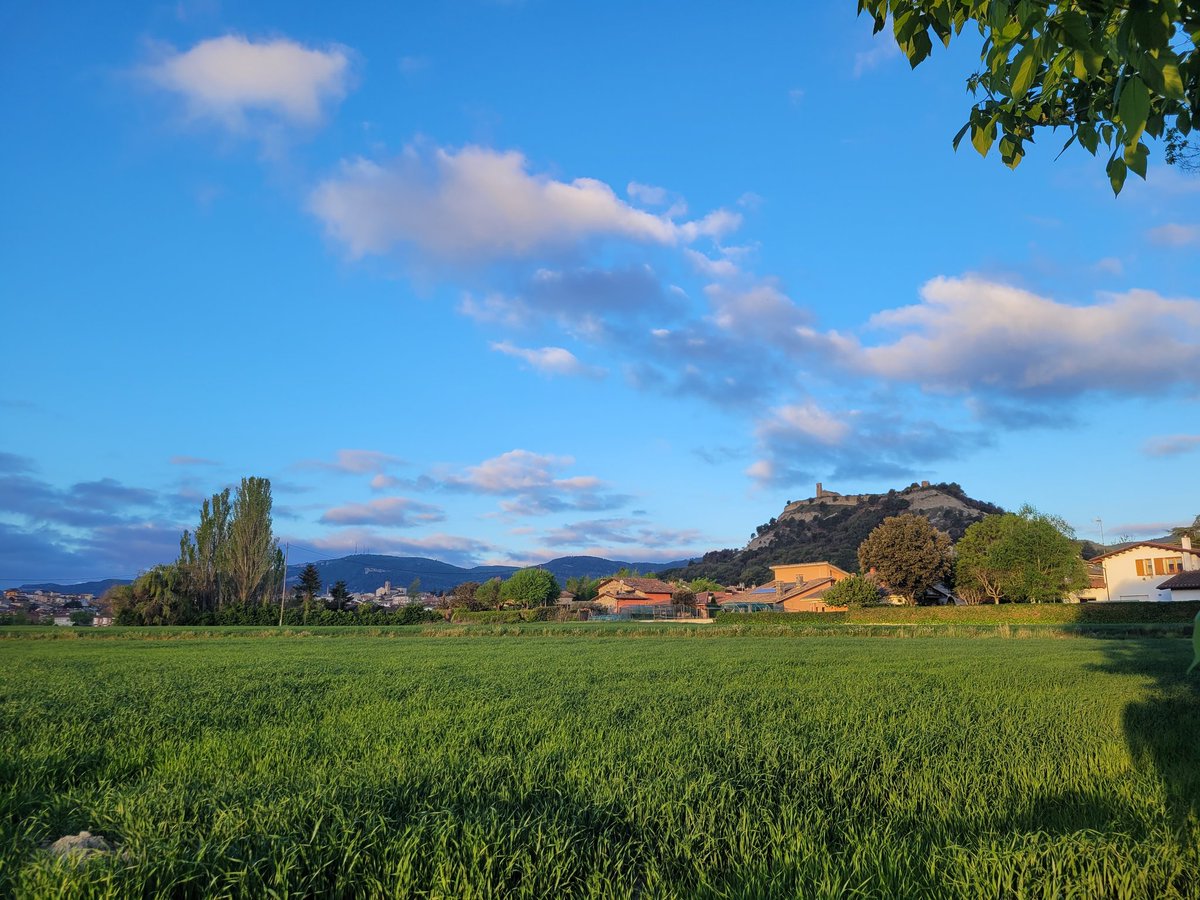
xmin=854 ymin=277 xmax=1200 ymax=397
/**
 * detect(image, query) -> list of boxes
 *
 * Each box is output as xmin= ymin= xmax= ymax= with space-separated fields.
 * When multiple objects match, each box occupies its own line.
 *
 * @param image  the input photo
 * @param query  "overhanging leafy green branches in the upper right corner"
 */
xmin=858 ymin=0 xmax=1200 ymax=193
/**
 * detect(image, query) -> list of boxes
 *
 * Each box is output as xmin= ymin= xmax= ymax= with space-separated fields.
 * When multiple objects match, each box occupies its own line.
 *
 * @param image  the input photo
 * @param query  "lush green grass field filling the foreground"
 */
xmin=0 ymin=626 xmax=1200 ymax=898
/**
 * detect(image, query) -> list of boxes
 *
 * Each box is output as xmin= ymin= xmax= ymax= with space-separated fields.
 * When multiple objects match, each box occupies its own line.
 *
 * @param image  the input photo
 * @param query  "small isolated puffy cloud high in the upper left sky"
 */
xmin=142 ymin=35 xmax=350 ymax=131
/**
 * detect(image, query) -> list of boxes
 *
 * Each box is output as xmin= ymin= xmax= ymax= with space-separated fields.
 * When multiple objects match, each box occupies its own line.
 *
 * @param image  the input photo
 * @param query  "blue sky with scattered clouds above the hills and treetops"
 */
xmin=0 ymin=0 xmax=1200 ymax=583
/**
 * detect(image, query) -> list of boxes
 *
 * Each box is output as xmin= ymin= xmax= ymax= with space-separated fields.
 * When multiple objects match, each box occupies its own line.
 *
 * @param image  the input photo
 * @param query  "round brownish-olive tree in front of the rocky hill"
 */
xmin=858 ymin=512 xmax=950 ymax=605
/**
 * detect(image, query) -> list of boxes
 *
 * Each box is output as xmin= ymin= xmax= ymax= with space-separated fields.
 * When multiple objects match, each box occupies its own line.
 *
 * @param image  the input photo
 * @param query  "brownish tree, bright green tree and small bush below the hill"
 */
xmin=840 ymin=505 xmax=1087 ymax=606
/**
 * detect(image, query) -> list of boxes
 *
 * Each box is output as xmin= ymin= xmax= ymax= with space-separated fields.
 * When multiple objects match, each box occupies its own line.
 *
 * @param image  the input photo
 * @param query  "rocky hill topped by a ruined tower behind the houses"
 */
xmin=665 ymin=481 xmax=1003 ymax=584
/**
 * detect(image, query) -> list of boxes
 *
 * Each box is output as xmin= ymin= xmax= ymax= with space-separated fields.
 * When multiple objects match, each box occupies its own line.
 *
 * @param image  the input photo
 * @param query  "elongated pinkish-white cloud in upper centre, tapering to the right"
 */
xmin=310 ymin=145 xmax=740 ymax=262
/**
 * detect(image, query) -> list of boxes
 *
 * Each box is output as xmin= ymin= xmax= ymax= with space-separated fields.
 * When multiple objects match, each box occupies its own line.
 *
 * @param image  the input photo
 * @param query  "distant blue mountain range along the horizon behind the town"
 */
xmin=18 ymin=553 xmax=686 ymax=596
